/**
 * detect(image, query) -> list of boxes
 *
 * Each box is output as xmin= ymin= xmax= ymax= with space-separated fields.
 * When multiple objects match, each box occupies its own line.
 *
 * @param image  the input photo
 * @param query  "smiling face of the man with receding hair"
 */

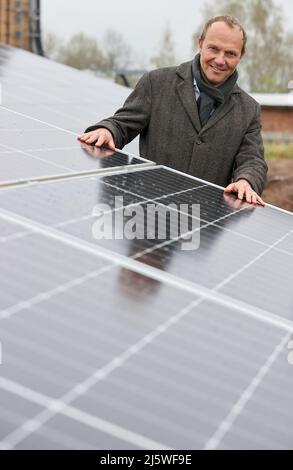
xmin=198 ymin=21 xmax=243 ymax=86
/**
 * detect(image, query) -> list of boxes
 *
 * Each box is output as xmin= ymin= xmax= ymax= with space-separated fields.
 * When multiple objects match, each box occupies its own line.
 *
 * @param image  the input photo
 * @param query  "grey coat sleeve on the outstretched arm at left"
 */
xmin=85 ymin=73 xmax=151 ymax=149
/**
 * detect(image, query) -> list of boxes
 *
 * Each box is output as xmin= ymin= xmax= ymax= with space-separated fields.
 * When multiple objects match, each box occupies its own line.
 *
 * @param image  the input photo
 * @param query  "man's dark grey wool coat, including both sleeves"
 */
xmin=87 ymin=61 xmax=267 ymax=194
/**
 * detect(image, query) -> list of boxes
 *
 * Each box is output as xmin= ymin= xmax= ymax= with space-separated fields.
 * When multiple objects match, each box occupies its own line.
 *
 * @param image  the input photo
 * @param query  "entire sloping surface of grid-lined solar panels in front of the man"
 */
xmin=0 ymin=48 xmax=293 ymax=449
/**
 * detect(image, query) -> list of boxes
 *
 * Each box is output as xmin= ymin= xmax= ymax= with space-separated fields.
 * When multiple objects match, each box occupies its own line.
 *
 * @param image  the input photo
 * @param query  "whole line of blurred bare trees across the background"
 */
xmin=44 ymin=0 xmax=293 ymax=93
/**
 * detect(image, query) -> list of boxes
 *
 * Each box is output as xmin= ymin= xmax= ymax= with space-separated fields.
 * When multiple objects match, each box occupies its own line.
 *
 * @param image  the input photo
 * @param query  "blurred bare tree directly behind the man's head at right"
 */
xmin=193 ymin=0 xmax=293 ymax=93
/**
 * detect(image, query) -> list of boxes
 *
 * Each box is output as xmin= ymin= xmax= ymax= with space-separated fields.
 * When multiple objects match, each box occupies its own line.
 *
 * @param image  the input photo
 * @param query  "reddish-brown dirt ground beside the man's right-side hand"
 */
xmin=262 ymin=158 xmax=293 ymax=212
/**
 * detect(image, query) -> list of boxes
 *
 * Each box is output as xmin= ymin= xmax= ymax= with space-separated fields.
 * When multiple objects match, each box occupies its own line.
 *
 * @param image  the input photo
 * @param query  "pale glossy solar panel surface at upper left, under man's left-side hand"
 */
xmin=0 ymin=46 xmax=152 ymax=184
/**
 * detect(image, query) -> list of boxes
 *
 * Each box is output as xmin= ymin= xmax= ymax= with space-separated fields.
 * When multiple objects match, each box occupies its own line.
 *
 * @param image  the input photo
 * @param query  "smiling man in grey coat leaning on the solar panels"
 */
xmin=78 ymin=16 xmax=267 ymax=205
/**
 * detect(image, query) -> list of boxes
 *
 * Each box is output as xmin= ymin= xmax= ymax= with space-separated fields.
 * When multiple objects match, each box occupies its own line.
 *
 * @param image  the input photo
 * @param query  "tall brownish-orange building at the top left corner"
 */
xmin=0 ymin=0 xmax=44 ymax=55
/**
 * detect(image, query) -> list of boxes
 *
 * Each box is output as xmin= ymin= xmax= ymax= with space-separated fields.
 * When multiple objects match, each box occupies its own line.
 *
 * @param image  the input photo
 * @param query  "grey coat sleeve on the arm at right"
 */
xmin=233 ymin=103 xmax=268 ymax=195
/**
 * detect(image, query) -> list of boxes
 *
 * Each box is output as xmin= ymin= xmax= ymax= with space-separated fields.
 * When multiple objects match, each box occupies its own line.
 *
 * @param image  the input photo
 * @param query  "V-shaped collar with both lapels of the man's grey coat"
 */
xmin=176 ymin=61 xmax=241 ymax=133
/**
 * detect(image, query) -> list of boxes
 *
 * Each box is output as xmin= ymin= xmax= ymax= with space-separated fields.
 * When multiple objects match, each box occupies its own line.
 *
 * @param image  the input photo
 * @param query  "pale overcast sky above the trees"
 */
xmin=41 ymin=0 xmax=293 ymax=61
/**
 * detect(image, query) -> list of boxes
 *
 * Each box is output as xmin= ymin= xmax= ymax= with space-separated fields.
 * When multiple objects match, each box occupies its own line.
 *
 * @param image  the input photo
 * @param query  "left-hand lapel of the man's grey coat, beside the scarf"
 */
xmin=177 ymin=62 xmax=201 ymax=132
